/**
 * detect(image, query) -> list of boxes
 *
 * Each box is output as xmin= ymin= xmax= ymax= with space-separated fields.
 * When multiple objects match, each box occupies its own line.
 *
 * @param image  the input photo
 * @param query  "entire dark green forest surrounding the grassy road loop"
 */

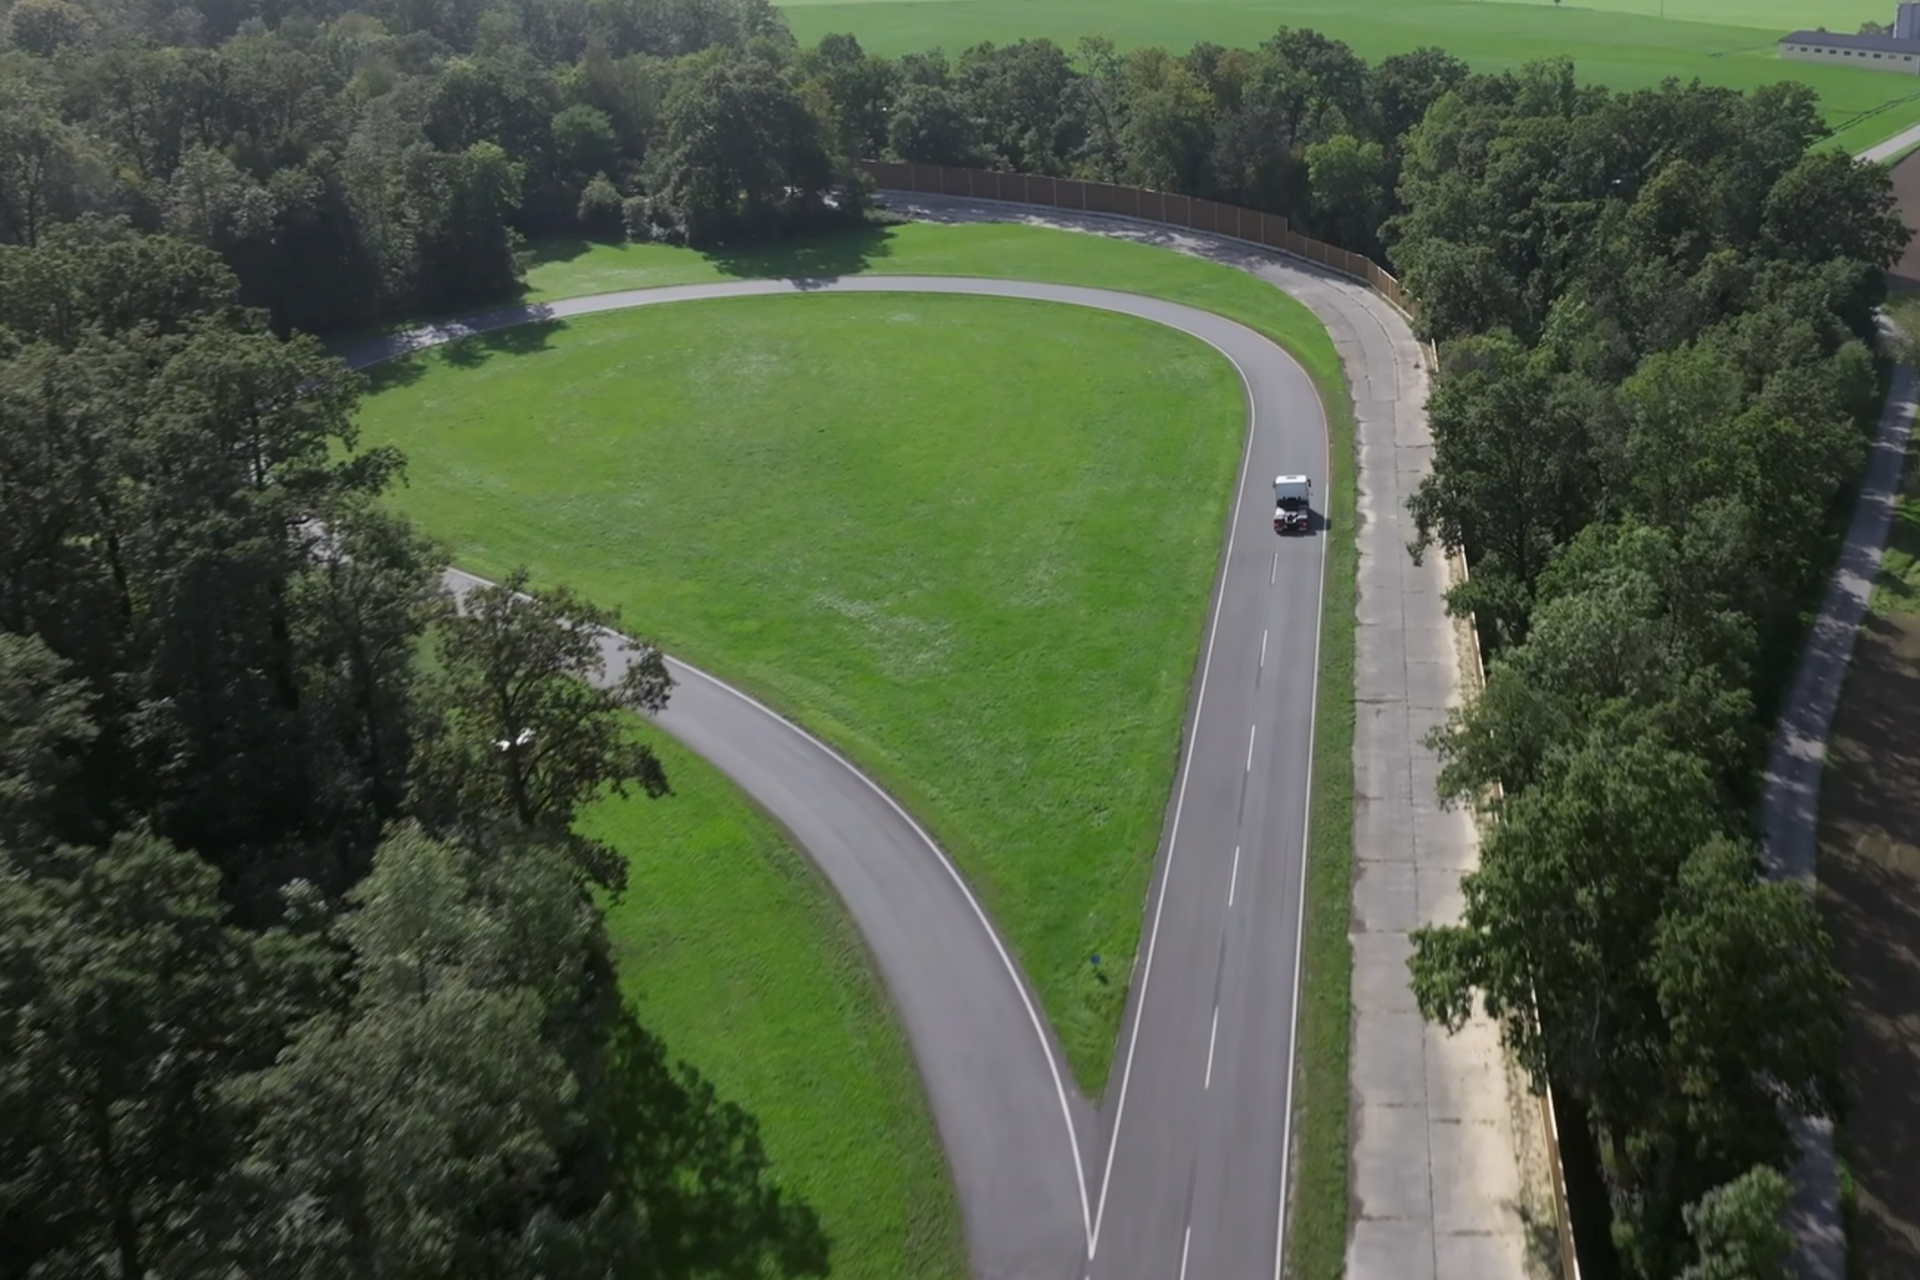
xmin=0 ymin=0 xmax=1910 ymax=1280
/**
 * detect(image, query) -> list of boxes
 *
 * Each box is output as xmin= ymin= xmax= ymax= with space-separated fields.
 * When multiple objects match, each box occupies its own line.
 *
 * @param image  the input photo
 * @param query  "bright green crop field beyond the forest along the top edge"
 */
xmin=781 ymin=0 xmax=1920 ymax=152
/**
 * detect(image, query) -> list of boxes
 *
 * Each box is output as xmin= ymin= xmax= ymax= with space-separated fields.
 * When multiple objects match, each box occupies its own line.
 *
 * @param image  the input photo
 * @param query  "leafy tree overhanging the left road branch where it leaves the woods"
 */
xmin=420 ymin=570 xmax=674 ymax=875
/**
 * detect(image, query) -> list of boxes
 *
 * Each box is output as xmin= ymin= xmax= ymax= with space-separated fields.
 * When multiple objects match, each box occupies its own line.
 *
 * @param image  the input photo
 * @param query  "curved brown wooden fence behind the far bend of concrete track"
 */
xmin=860 ymin=159 xmax=1415 ymax=315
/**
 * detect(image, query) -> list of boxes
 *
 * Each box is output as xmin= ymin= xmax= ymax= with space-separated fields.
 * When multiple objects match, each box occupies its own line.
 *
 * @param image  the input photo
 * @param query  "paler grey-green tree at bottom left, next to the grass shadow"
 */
xmin=227 ymin=827 xmax=639 ymax=1280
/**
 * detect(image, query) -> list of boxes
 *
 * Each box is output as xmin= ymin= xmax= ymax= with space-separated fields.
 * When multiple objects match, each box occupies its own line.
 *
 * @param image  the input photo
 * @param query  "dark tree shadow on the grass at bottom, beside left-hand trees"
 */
xmin=605 ymin=1009 xmax=831 ymax=1280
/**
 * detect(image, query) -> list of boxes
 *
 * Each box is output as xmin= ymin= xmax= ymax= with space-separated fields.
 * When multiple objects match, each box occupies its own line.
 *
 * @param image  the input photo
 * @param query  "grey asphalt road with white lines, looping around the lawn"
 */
xmin=348 ymin=276 xmax=1329 ymax=1280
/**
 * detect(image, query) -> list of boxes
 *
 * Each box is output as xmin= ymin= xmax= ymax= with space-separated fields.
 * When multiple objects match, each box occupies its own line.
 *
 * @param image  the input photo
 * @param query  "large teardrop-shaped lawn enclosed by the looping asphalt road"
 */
xmin=361 ymin=285 xmax=1246 ymax=1094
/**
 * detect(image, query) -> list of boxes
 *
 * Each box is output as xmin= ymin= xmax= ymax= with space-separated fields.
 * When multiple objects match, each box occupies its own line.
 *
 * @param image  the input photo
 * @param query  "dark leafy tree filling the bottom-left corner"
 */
xmin=0 ymin=833 xmax=288 ymax=1276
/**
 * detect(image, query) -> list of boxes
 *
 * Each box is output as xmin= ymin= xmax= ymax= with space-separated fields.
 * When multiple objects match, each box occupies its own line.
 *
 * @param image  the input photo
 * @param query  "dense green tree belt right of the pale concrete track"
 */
xmin=1382 ymin=45 xmax=1908 ymax=1280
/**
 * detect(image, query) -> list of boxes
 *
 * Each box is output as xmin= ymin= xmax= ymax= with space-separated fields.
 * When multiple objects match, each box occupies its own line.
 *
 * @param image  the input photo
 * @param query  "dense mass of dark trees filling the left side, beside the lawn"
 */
xmin=0 ymin=217 xmax=828 ymax=1280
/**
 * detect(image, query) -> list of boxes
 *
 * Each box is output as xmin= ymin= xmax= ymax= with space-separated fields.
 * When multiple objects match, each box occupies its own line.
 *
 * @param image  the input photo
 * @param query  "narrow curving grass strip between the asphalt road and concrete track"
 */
xmin=382 ymin=225 xmax=1356 ymax=1280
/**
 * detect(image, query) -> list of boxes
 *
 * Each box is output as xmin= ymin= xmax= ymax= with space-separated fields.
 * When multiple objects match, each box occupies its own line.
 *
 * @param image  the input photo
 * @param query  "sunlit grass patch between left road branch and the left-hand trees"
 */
xmin=582 ymin=731 xmax=968 ymax=1280
